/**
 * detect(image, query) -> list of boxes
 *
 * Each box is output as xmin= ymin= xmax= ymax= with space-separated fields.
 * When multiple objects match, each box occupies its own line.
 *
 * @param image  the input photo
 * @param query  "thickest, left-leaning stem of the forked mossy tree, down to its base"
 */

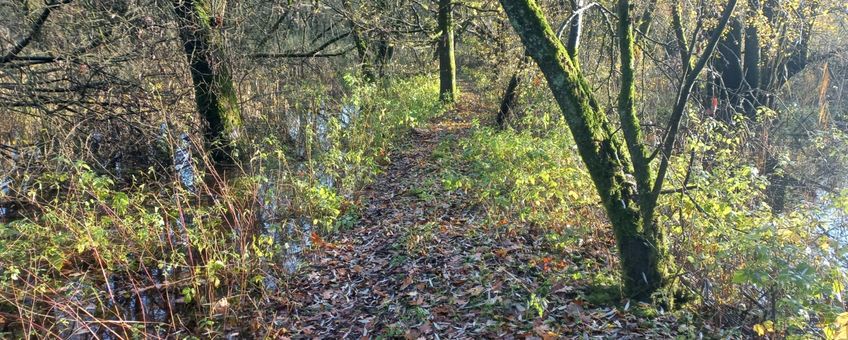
xmin=501 ymin=0 xmax=667 ymax=301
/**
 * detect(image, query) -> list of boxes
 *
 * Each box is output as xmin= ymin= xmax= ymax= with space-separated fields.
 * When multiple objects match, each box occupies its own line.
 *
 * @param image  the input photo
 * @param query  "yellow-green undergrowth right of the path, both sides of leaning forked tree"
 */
xmin=435 ymin=115 xmax=848 ymax=338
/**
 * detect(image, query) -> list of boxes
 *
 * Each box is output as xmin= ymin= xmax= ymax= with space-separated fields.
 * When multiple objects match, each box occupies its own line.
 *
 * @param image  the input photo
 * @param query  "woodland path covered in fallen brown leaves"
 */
xmin=273 ymin=93 xmax=684 ymax=338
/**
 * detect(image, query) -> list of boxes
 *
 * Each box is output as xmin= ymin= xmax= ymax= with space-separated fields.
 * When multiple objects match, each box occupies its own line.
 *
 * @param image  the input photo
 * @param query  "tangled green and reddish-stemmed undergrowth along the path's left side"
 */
xmin=0 ymin=76 xmax=441 ymax=338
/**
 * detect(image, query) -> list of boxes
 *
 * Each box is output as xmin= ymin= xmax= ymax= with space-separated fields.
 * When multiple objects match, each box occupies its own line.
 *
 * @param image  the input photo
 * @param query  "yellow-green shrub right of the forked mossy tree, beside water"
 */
xmin=659 ymin=120 xmax=848 ymax=335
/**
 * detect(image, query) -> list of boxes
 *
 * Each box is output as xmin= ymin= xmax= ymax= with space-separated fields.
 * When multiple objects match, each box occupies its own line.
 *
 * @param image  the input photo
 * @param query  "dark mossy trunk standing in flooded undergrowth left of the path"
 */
xmin=172 ymin=0 xmax=242 ymax=165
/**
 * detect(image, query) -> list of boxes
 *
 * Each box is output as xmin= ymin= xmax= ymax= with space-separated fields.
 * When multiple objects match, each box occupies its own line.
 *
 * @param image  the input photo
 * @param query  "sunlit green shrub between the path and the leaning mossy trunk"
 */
xmin=443 ymin=119 xmax=598 ymax=225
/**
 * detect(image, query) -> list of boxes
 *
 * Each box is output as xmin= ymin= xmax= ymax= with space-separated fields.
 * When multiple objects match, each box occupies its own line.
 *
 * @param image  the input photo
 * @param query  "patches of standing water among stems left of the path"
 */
xmin=0 ymin=105 xmax=359 ymax=339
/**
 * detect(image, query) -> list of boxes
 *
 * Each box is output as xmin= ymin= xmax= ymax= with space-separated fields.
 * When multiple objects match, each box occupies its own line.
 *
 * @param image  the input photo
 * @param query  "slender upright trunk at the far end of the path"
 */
xmin=438 ymin=0 xmax=457 ymax=103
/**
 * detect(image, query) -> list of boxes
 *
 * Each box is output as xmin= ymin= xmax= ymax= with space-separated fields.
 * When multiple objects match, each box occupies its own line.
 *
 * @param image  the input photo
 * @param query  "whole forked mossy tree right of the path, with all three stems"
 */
xmin=500 ymin=0 xmax=736 ymax=302
